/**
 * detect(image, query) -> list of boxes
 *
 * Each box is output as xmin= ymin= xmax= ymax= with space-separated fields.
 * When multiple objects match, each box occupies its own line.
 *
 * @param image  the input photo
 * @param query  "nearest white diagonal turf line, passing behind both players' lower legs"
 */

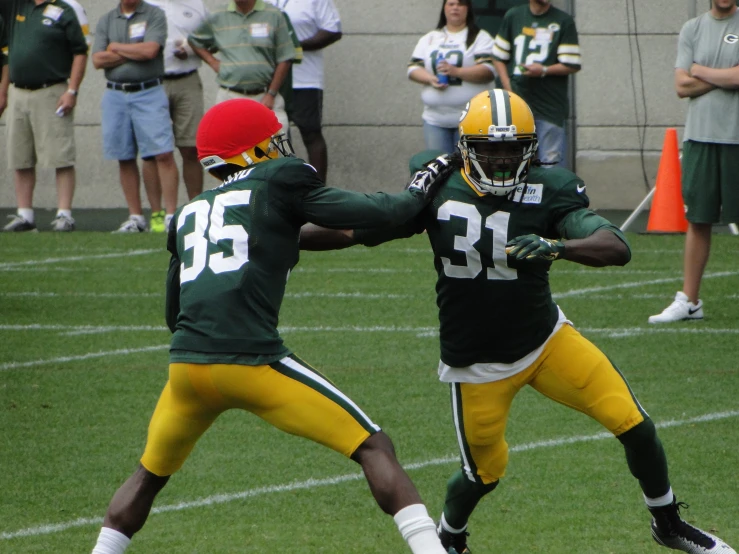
xmin=0 ymin=411 xmax=739 ymax=540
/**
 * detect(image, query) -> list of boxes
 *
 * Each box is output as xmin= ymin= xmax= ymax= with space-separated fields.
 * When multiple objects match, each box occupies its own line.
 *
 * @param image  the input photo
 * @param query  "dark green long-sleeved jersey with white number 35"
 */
xmin=166 ymin=158 xmax=425 ymax=365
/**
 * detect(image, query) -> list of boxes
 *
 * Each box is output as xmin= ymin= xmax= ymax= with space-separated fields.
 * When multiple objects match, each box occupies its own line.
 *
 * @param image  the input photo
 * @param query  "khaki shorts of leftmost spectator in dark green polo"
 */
xmin=7 ymin=83 xmax=76 ymax=169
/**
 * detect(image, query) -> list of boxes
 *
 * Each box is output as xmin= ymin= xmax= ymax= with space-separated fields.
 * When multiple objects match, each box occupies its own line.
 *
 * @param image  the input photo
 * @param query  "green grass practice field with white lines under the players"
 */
xmin=0 ymin=232 xmax=739 ymax=554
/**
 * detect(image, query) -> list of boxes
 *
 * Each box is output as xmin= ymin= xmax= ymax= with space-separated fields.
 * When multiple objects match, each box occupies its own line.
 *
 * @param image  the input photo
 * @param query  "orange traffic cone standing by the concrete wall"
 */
xmin=647 ymin=128 xmax=688 ymax=233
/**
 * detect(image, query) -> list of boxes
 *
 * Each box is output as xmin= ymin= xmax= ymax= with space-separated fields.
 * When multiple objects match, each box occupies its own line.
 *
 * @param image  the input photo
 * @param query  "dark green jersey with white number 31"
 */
xmin=358 ymin=153 xmax=626 ymax=374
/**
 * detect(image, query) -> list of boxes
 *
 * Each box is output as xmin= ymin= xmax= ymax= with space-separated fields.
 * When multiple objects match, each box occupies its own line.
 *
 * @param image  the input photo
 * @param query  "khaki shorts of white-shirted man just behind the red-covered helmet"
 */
xmin=164 ymin=71 xmax=205 ymax=148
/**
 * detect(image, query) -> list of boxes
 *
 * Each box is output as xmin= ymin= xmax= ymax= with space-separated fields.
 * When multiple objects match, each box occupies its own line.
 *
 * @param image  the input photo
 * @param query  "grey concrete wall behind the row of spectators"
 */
xmin=0 ymin=0 xmax=708 ymax=208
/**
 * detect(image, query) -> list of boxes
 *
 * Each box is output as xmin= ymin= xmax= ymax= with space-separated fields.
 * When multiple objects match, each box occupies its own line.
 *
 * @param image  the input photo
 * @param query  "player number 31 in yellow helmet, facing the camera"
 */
xmin=301 ymin=89 xmax=735 ymax=554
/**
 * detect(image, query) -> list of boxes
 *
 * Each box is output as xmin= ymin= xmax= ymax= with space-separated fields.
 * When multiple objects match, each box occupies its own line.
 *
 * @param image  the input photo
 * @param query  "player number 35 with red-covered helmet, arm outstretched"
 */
xmin=93 ymin=99 xmax=451 ymax=554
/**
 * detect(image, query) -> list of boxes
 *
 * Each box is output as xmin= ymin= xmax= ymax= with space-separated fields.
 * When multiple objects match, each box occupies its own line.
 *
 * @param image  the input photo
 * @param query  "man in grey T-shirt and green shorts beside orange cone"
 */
xmin=649 ymin=0 xmax=739 ymax=323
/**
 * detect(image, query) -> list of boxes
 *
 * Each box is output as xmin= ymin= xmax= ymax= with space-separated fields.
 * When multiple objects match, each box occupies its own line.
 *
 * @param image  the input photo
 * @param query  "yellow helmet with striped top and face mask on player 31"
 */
xmin=459 ymin=88 xmax=538 ymax=196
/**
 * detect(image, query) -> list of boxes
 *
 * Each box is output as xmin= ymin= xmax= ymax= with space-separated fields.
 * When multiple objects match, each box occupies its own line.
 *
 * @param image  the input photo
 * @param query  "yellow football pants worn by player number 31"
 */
xmin=451 ymin=325 xmax=646 ymax=484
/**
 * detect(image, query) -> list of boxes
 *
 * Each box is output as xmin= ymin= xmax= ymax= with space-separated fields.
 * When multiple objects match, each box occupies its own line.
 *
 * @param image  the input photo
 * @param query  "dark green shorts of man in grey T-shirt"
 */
xmin=682 ymin=140 xmax=739 ymax=223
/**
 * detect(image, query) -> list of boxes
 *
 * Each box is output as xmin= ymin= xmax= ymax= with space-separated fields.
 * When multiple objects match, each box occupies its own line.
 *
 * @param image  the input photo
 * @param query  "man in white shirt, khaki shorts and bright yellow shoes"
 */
xmin=142 ymin=0 xmax=208 ymax=232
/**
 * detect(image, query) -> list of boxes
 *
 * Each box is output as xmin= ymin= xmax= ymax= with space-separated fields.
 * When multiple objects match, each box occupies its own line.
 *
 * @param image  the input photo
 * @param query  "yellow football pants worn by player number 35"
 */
xmin=141 ymin=356 xmax=380 ymax=477
